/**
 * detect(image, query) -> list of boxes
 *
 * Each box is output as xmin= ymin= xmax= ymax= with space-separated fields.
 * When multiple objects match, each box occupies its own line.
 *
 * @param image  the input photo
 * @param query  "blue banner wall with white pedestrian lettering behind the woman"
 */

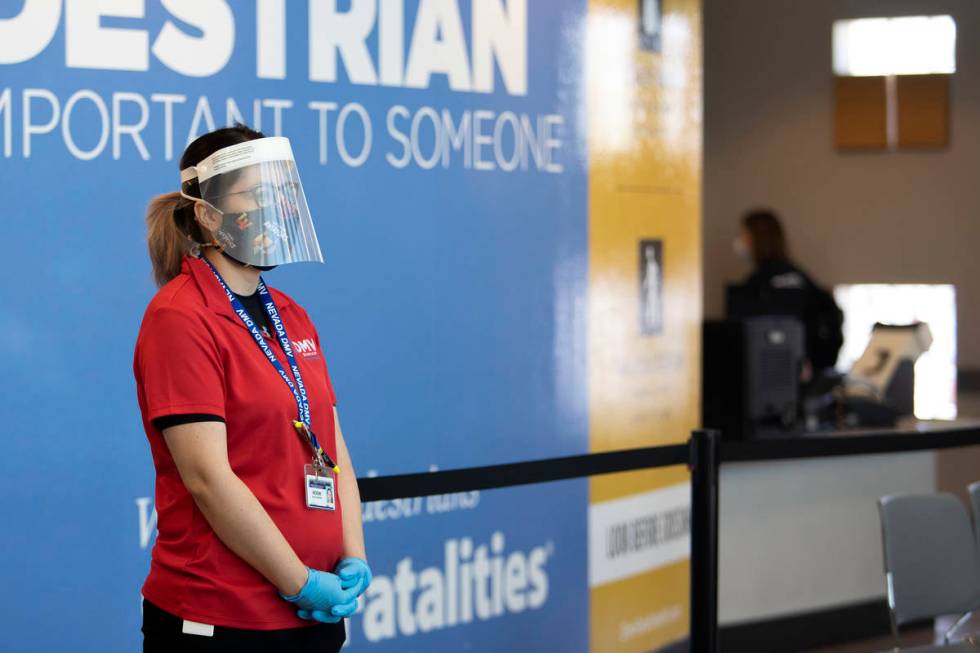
xmin=0 ymin=0 xmax=589 ymax=653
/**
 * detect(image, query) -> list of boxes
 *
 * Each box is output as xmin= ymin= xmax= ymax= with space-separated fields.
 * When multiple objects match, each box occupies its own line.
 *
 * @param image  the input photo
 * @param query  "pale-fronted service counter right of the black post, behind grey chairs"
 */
xmin=718 ymin=420 xmax=980 ymax=640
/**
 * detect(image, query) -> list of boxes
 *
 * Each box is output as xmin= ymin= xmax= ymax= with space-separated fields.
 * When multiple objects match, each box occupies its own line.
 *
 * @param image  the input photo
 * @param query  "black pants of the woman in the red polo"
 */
xmin=143 ymin=599 xmax=347 ymax=653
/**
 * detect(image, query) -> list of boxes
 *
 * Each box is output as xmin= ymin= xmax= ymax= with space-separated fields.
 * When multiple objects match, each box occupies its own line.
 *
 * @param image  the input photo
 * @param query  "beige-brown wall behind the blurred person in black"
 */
xmin=704 ymin=0 xmax=980 ymax=368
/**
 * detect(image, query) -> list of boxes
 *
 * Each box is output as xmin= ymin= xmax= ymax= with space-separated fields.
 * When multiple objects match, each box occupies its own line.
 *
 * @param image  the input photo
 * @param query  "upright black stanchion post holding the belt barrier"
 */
xmin=691 ymin=430 xmax=720 ymax=653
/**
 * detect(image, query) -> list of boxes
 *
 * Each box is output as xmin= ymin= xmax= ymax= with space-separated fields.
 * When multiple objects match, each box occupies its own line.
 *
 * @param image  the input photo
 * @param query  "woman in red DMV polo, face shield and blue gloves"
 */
xmin=133 ymin=125 xmax=371 ymax=653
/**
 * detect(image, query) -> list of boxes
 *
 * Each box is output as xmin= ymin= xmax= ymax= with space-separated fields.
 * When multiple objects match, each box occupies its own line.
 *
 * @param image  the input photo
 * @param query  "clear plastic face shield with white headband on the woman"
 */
xmin=180 ymin=136 xmax=323 ymax=267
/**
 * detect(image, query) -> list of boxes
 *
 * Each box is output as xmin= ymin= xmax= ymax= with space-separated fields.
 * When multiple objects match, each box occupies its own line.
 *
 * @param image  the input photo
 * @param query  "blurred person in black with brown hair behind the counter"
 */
xmin=726 ymin=209 xmax=844 ymax=382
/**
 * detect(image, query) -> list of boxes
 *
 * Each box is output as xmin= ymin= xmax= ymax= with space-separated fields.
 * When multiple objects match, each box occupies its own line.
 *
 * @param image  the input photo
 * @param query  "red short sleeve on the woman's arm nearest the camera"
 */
xmin=136 ymin=308 xmax=225 ymax=421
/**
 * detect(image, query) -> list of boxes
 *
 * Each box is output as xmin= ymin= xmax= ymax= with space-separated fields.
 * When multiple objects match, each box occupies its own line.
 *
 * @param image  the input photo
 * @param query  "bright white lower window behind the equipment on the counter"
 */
xmin=834 ymin=284 xmax=956 ymax=419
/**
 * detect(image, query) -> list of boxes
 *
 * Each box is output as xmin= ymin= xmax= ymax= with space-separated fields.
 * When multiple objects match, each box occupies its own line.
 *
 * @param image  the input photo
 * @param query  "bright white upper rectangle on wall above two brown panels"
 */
xmin=833 ymin=16 xmax=956 ymax=77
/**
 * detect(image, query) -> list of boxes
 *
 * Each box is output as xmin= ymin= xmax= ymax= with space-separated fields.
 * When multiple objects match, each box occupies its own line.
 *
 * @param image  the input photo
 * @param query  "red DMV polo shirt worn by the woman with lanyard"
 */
xmin=133 ymin=257 xmax=343 ymax=630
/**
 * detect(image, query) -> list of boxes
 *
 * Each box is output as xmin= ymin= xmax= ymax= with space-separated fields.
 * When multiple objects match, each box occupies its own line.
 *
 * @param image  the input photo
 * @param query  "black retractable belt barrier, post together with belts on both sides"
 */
xmin=358 ymin=425 xmax=980 ymax=653
